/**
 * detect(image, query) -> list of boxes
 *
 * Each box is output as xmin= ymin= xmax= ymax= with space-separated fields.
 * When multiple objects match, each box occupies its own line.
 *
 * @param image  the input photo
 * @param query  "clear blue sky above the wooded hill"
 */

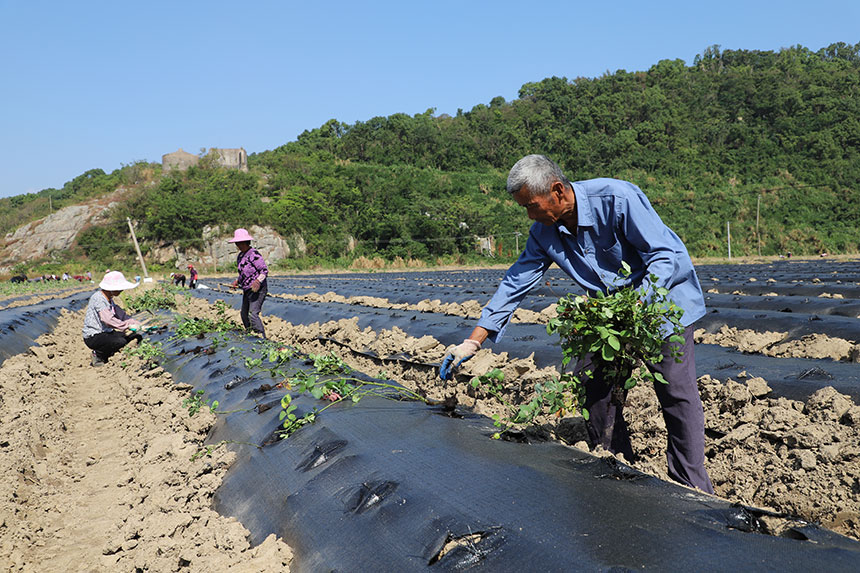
xmin=0 ymin=0 xmax=860 ymax=196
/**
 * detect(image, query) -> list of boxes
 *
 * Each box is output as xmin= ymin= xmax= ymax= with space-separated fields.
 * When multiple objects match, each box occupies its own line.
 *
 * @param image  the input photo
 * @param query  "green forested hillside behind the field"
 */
xmin=0 ymin=43 xmax=860 ymax=268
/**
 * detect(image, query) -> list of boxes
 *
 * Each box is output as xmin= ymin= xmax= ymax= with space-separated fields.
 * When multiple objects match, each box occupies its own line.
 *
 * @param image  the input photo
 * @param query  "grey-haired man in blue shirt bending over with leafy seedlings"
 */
xmin=439 ymin=155 xmax=714 ymax=493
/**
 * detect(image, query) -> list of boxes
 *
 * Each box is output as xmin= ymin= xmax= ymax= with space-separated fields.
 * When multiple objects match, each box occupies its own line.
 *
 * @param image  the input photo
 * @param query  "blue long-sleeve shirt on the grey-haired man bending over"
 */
xmin=478 ymin=178 xmax=705 ymax=342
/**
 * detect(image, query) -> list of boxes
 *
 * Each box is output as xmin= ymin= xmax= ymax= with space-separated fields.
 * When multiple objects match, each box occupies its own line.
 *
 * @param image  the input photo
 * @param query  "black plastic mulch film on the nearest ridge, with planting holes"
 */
xmin=146 ymin=320 xmax=860 ymax=571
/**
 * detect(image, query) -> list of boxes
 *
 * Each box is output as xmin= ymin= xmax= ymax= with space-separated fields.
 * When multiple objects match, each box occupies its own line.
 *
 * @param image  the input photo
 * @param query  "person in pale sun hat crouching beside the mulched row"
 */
xmin=83 ymin=271 xmax=141 ymax=366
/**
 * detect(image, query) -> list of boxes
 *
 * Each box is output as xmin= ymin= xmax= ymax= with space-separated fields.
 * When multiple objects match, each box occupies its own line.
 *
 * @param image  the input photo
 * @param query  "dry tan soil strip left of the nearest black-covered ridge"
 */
xmin=0 ymin=312 xmax=291 ymax=571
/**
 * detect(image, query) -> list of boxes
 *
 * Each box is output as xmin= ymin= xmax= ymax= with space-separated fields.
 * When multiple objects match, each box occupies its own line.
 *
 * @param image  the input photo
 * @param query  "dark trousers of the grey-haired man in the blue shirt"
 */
xmin=577 ymin=326 xmax=714 ymax=493
